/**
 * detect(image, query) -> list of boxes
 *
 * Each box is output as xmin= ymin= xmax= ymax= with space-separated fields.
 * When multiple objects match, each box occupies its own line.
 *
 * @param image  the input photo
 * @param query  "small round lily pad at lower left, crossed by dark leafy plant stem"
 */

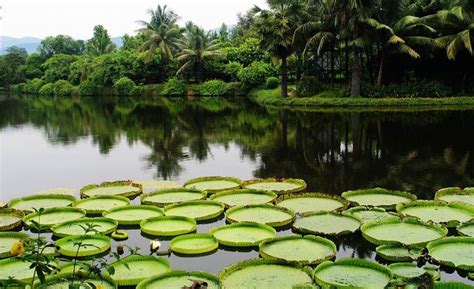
xmin=55 ymin=235 xmax=110 ymax=257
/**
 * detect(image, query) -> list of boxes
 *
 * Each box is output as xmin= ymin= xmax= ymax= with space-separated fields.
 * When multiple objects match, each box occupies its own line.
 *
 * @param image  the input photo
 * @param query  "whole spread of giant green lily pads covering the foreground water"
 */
xmin=0 ymin=177 xmax=474 ymax=289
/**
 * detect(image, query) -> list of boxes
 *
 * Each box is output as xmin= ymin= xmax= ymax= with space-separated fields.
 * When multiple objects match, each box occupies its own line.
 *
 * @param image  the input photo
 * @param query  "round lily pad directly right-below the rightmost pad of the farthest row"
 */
xmin=277 ymin=193 xmax=349 ymax=213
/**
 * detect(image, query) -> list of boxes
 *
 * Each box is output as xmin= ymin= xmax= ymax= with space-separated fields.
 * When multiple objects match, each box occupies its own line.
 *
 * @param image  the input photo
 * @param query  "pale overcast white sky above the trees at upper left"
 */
xmin=0 ymin=0 xmax=265 ymax=39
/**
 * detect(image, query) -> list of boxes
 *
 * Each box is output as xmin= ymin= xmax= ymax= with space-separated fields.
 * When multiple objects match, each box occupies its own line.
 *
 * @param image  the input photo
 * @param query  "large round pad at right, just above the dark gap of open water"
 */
xmin=361 ymin=218 xmax=448 ymax=247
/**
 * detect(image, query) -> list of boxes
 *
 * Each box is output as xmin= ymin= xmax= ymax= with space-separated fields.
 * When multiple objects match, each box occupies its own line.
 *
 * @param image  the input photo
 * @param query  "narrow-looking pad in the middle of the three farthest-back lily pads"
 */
xmin=184 ymin=177 xmax=242 ymax=194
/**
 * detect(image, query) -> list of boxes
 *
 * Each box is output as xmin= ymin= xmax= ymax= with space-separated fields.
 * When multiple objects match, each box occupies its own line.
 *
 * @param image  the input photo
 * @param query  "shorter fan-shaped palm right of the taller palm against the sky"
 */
xmin=176 ymin=22 xmax=222 ymax=83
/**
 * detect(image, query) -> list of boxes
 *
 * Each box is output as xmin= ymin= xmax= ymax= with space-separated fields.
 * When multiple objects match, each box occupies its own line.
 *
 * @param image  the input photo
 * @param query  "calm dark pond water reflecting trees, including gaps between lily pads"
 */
xmin=0 ymin=97 xmax=474 ymax=282
